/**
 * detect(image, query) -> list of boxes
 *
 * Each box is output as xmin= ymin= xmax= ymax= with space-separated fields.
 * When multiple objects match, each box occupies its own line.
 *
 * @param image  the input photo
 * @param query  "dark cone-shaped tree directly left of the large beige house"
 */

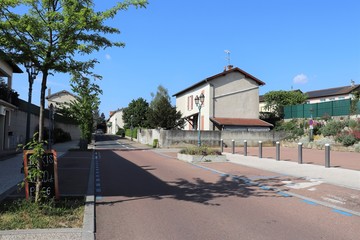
xmin=147 ymin=85 xmax=185 ymax=129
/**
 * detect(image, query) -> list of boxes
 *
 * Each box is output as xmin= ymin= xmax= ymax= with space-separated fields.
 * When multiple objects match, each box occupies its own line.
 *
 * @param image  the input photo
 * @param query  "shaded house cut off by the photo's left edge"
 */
xmin=0 ymin=51 xmax=23 ymax=150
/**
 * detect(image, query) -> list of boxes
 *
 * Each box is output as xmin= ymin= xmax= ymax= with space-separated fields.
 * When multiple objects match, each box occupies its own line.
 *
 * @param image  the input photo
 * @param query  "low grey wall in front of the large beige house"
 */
xmin=137 ymin=129 xmax=286 ymax=148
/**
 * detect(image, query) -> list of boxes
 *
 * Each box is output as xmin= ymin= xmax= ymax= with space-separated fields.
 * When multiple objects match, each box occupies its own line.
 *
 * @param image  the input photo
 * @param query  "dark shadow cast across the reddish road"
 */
xmin=97 ymin=150 xmax=282 ymax=205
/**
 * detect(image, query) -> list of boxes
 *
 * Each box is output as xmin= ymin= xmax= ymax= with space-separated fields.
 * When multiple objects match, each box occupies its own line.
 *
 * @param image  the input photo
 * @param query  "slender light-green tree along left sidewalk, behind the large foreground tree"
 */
xmin=61 ymin=69 xmax=102 ymax=149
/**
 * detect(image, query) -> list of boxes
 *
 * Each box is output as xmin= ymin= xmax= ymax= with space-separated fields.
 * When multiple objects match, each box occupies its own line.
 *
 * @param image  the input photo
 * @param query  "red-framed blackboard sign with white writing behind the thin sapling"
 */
xmin=24 ymin=150 xmax=59 ymax=199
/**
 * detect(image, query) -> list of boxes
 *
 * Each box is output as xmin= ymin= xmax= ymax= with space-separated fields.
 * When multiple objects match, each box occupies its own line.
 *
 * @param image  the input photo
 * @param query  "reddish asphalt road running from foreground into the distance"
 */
xmin=95 ymin=136 xmax=360 ymax=240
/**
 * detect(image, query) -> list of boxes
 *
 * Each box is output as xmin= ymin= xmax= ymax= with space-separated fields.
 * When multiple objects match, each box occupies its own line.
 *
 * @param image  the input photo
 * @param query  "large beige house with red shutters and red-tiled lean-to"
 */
xmin=173 ymin=65 xmax=272 ymax=131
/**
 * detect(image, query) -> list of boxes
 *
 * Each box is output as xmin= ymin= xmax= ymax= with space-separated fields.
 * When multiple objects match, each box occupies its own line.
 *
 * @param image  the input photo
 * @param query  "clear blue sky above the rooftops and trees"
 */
xmin=13 ymin=0 xmax=360 ymax=117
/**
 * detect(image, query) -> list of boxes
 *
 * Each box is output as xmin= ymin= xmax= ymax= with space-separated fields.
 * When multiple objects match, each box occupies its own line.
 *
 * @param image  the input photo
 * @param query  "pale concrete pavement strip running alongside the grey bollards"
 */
xmin=223 ymin=153 xmax=360 ymax=190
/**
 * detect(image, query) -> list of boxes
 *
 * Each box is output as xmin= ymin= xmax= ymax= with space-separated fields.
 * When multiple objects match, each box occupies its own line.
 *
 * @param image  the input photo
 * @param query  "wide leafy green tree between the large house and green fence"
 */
xmin=264 ymin=90 xmax=307 ymax=118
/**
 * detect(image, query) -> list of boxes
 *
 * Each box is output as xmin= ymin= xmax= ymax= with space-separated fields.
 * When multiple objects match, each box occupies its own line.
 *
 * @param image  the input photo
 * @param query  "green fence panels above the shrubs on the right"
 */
xmin=284 ymin=99 xmax=360 ymax=119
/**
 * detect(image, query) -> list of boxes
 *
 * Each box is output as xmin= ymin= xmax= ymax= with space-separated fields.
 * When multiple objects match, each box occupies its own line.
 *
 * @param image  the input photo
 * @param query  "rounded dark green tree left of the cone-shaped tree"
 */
xmin=122 ymin=98 xmax=149 ymax=129
